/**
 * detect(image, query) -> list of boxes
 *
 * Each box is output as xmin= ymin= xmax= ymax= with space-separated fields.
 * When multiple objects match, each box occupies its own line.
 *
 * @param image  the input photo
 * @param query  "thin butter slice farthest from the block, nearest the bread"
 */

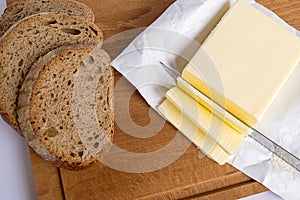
xmin=158 ymin=100 xmax=230 ymax=165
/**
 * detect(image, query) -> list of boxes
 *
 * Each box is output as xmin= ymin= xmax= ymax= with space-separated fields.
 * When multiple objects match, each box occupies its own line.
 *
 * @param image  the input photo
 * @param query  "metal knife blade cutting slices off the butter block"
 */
xmin=159 ymin=62 xmax=300 ymax=172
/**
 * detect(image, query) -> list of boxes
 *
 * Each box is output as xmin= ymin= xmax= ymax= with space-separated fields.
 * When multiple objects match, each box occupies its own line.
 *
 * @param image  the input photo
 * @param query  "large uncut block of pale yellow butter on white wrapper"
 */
xmin=182 ymin=0 xmax=300 ymax=126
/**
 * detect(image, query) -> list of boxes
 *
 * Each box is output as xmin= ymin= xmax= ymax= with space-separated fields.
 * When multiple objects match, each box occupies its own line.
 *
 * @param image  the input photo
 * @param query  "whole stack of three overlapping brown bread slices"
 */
xmin=0 ymin=0 xmax=113 ymax=170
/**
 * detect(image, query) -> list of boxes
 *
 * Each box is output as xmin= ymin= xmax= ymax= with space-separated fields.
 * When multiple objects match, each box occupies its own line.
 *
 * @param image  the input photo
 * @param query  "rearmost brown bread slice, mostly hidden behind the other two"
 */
xmin=0 ymin=0 xmax=95 ymax=37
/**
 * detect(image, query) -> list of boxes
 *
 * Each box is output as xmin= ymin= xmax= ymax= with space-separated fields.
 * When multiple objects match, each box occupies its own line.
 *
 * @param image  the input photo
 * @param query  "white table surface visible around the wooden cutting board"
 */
xmin=0 ymin=0 xmax=281 ymax=200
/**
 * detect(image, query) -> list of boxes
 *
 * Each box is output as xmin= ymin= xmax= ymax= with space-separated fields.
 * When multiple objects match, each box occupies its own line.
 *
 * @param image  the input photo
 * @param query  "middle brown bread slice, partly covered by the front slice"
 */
xmin=0 ymin=13 xmax=103 ymax=131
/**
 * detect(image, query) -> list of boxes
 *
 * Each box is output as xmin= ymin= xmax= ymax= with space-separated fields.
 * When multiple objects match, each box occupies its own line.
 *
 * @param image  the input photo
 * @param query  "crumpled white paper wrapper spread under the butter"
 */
xmin=112 ymin=0 xmax=300 ymax=199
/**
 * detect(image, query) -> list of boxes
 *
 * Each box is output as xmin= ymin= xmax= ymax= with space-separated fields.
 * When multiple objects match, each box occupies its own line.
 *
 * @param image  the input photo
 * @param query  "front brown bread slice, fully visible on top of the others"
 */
xmin=18 ymin=46 xmax=113 ymax=170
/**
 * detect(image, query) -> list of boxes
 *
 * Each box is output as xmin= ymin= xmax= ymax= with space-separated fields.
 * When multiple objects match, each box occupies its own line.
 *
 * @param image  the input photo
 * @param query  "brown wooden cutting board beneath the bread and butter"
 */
xmin=8 ymin=0 xmax=300 ymax=200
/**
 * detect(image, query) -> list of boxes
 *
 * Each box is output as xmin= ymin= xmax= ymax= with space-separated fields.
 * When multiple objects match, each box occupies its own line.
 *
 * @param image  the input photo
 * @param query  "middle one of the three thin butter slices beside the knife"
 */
xmin=166 ymin=87 xmax=243 ymax=155
